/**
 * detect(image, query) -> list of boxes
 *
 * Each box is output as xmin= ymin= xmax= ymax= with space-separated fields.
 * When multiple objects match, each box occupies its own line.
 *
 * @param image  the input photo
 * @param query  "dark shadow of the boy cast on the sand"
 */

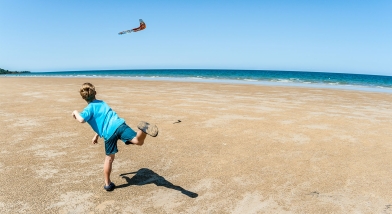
xmin=116 ymin=168 xmax=199 ymax=198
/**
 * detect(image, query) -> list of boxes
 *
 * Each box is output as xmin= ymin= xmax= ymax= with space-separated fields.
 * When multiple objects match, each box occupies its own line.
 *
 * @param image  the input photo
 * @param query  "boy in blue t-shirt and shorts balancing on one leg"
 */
xmin=72 ymin=83 xmax=158 ymax=191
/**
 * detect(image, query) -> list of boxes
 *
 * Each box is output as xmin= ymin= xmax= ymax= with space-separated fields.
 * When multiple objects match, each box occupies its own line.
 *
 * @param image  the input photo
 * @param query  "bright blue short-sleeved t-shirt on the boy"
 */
xmin=80 ymin=100 xmax=125 ymax=140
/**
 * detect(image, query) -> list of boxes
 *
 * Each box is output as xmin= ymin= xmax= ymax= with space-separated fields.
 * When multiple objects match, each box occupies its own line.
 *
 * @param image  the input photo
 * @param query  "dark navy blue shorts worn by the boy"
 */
xmin=105 ymin=123 xmax=136 ymax=155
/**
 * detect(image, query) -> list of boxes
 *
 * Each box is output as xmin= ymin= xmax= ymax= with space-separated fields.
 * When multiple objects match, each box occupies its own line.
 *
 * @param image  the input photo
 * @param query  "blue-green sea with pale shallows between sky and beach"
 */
xmin=6 ymin=69 xmax=392 ymax=93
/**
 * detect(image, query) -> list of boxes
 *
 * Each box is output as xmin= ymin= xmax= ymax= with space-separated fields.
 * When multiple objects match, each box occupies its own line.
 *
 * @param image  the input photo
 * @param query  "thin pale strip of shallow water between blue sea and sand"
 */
xmin=0 ymin=75 xmax=392 ymax=94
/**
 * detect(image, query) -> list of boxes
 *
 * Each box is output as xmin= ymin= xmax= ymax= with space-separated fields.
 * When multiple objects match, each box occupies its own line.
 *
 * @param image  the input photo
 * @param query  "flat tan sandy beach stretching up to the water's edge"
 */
xmin=0 ymin=77 xmax=392 ymax=213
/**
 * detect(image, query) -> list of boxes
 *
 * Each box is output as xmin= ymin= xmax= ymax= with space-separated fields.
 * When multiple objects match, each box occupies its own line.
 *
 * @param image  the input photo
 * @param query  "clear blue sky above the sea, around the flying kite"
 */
xmin=0 ymin=0 xmax=392 ymax=76
